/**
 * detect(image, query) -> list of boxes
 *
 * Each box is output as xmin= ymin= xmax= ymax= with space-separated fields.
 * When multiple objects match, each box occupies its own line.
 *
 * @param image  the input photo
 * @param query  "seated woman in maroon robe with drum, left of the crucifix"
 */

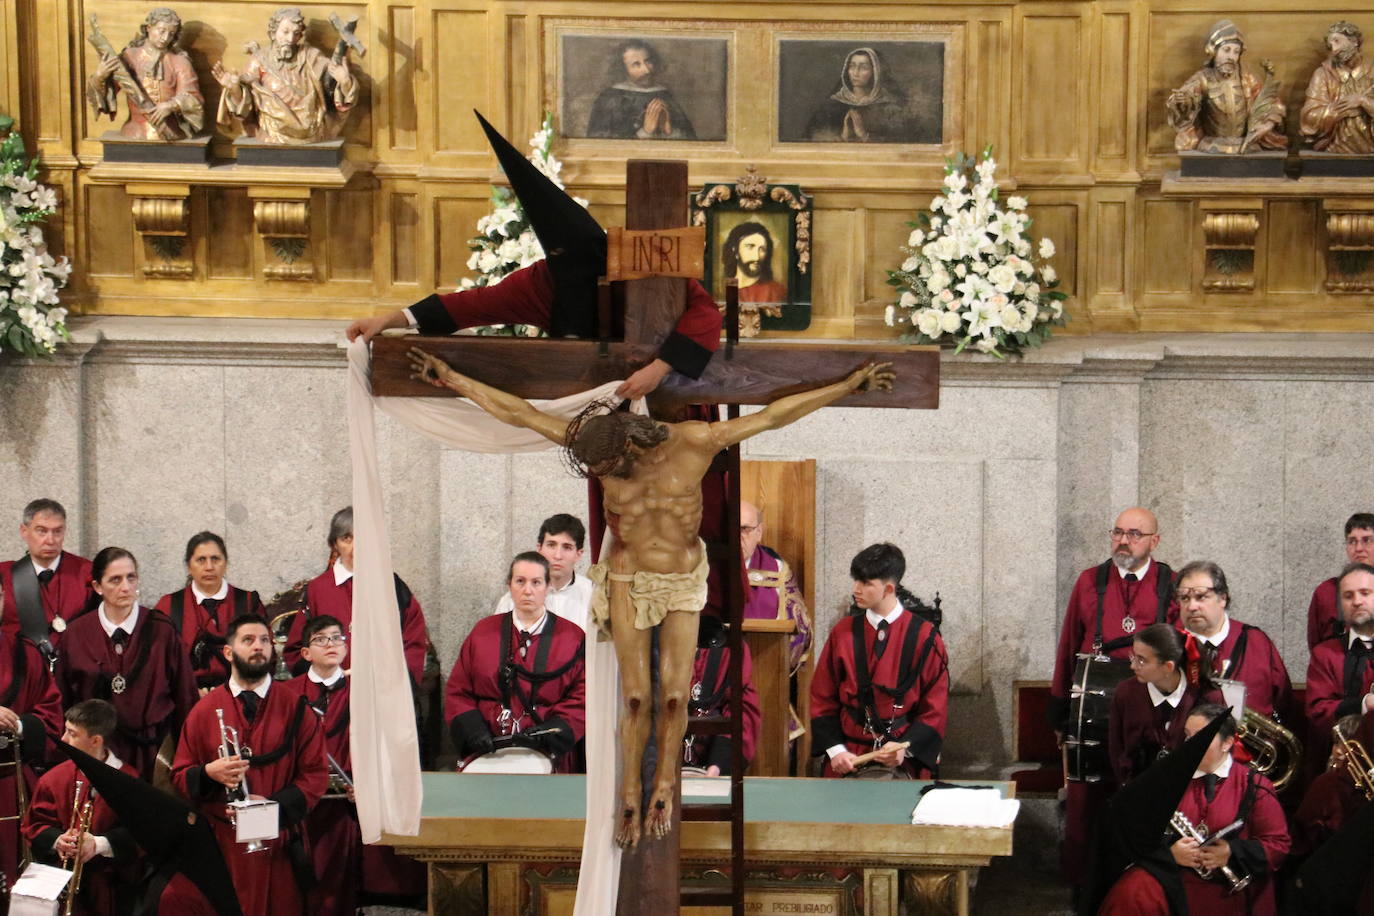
xmin=444 ymin=551 xmax=587 ymax=773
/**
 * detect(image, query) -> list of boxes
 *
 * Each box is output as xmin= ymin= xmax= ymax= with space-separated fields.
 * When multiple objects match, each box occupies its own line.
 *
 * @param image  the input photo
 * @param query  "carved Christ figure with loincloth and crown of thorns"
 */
xmin=411 ymin=349 xmax=896 ymax=846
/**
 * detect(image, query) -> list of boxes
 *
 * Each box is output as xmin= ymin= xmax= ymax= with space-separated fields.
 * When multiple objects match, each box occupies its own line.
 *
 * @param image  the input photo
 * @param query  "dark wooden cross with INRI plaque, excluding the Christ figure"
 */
xmin=372 ymin=159 xmax=940 ymax=916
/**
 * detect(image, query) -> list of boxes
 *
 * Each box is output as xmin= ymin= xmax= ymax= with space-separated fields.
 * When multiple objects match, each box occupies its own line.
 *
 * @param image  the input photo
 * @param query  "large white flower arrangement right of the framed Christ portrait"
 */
xmin=885 ymin=147 xmax=1068 ymax=357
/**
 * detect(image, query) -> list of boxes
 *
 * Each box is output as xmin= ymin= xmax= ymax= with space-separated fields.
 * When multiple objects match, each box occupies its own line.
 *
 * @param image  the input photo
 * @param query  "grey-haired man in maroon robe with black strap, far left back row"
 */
xmin=0 ymin=499 xmax=91 ymax=661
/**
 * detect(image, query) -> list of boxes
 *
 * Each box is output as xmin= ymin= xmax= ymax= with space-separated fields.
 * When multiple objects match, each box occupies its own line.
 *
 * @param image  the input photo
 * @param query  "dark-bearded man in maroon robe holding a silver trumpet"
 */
xmin=162 ymin=614 xmax=328 ymax=916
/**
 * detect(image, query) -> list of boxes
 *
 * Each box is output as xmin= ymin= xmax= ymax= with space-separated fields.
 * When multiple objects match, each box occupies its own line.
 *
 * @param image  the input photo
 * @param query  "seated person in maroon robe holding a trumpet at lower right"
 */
xmin=1169 ymin=703 xmax=1289 ymax=916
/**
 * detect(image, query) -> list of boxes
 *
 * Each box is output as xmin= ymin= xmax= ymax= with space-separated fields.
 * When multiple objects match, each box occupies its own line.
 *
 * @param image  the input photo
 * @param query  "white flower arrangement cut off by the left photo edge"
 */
xmin=0 ymin=115 xmax=71 ymax=356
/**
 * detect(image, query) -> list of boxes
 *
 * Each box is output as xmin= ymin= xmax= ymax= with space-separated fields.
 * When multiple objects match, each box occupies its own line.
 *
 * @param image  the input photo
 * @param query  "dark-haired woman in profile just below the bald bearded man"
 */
xmin=1107 ymin=623 xmax=1217 ymax=784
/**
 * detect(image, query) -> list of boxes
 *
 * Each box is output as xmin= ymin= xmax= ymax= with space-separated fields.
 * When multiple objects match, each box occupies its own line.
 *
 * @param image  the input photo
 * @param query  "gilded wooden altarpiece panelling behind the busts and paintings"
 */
xmin=8 ymin=0 xmax=1374 ymax=338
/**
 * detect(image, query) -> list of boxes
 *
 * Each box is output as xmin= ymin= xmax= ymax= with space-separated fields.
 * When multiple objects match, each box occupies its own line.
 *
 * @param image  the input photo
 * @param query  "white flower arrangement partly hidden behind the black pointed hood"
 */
xmin=458 ymin=111 xmax=587 ymax=336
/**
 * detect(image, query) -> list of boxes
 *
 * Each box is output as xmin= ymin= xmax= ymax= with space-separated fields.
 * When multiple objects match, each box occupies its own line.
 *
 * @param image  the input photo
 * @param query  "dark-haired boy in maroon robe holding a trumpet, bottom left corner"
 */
xmin=22 ymin=700 xmax=139 ymax=916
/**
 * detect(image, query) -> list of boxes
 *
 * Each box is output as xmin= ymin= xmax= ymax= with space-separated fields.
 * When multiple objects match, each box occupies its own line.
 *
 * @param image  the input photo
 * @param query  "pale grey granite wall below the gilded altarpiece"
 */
xmin=0 ymin=319 xmax=1374 ymax=772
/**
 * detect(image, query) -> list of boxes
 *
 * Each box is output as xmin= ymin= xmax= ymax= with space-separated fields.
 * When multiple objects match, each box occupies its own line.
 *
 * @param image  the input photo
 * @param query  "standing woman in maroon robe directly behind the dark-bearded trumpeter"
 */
xmin=157 ymin=531 xmax=267 ymax=692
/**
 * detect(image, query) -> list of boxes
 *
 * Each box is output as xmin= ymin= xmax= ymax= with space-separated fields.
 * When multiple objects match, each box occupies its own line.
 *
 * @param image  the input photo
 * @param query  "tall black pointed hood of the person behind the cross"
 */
xmin=473 ymin=110 xmax=606 ymax=338
